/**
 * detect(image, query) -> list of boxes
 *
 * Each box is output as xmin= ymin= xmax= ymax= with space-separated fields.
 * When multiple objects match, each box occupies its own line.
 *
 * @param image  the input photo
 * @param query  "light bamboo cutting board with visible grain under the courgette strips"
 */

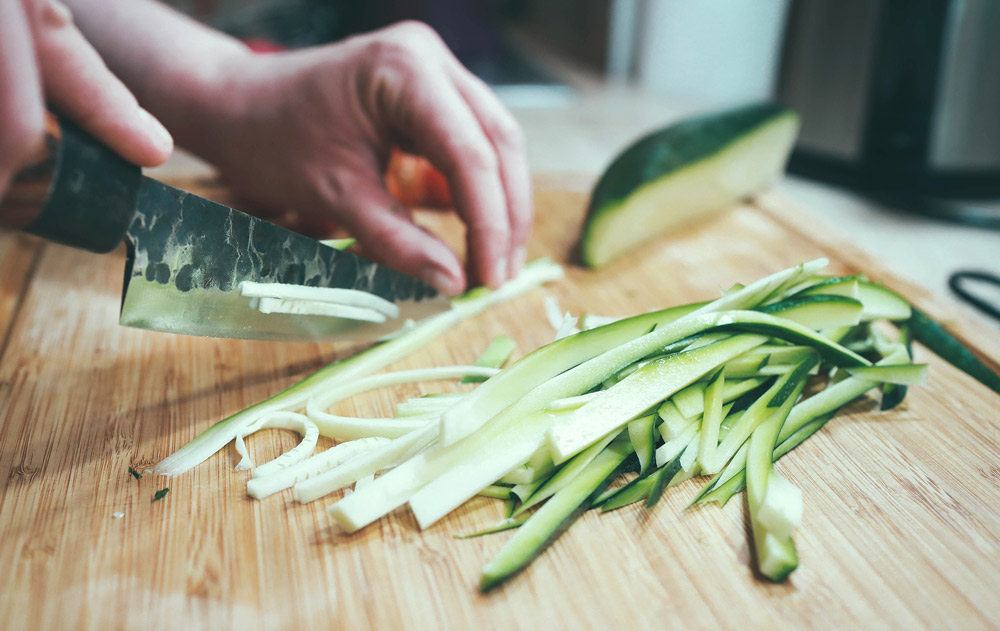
xmin=0 ymin=179 xmax=1000 ymax=630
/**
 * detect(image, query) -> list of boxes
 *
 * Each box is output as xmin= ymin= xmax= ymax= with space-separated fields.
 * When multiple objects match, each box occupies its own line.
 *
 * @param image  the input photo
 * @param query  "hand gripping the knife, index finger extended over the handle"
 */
xmin=0 ymin=0 xmax=173 ymax=206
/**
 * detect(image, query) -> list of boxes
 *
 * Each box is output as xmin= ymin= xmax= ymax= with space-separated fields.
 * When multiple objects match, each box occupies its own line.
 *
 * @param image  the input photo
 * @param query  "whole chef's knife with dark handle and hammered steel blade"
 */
xmin=0 ymin=113 xmax=449 ymax=341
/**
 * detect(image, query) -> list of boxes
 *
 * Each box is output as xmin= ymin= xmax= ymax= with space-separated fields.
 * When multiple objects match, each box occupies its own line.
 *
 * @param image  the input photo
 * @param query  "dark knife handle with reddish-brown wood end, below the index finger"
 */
xmin=0 ymin=114 xmax=142 ymax=252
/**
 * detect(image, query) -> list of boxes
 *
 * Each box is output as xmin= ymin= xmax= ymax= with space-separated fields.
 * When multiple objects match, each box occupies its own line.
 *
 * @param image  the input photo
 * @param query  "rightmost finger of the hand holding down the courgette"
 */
xmin=453 ymin=68 xmax=534 ymax=277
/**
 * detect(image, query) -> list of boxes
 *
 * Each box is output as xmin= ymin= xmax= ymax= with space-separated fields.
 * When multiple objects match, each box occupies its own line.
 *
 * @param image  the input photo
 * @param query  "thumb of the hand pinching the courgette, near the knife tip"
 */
xmin=320 ymin=168 xmax=465 ymax=296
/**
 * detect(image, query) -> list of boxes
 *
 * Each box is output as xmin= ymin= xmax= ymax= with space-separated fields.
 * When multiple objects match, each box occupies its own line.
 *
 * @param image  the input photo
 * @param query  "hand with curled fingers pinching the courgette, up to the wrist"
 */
xmin=189 ymin=23 xmax=532 ymax=295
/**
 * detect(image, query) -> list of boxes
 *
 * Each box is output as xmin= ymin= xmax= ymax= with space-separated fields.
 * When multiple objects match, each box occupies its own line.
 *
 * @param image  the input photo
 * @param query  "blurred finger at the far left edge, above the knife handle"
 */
xmin=0 ymin=2 xmax=45 ymax=197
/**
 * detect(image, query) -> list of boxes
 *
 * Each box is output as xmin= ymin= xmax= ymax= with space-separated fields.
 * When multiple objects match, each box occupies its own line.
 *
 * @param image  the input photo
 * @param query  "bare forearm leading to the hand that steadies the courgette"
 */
xmin=64 ymin=0 xmax=252 ymax=159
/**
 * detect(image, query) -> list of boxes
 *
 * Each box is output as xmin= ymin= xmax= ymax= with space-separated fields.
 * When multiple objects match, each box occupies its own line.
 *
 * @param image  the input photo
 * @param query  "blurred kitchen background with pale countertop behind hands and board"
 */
xmin=156 ymin=0 xmax=1000 ymax=320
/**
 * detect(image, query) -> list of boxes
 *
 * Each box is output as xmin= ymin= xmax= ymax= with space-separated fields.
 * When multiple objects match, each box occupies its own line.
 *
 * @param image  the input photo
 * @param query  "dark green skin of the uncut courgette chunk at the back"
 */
xmin=577 ymin=103 xmax=796 ymax=267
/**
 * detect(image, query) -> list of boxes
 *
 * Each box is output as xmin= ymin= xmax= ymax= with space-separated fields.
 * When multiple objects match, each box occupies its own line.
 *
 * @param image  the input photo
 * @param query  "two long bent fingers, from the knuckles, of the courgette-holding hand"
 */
xmin=362 ymin=24 xmax=531 ymax=287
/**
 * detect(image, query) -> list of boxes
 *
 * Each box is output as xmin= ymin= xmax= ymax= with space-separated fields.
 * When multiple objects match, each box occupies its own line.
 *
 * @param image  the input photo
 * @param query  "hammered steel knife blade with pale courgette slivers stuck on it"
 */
xmin=120 ymin=178 xmax=449 ymax=341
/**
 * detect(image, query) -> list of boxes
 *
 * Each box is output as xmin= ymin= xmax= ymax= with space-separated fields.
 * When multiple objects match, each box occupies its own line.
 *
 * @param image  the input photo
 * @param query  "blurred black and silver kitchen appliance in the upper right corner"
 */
xmin=777 ymin=0 xmax=1000 ymax=227
